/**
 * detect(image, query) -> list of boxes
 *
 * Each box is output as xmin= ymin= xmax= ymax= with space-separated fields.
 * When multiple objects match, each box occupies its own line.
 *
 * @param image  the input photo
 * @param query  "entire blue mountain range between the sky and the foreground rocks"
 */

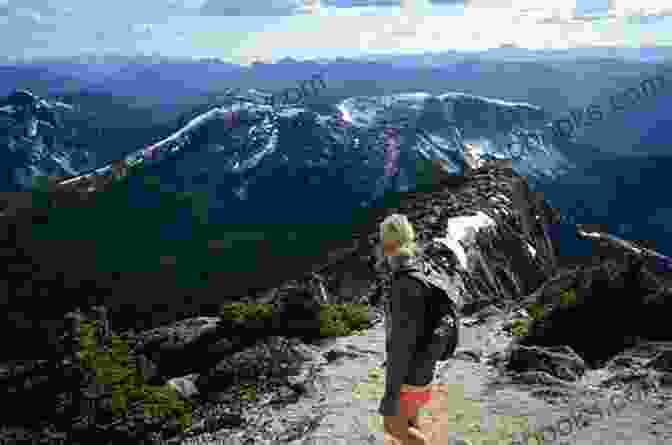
xmin=0 ymin=53 xmax=672 ymax=302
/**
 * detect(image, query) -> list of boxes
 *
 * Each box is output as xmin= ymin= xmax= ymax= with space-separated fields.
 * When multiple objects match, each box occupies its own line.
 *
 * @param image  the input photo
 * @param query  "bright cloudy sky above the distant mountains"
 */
xmin=0 ymin=0 xmax=672 ymax=64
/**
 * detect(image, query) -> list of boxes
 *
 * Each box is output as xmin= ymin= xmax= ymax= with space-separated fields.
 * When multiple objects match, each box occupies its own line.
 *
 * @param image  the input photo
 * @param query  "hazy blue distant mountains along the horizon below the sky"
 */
xmin=5 ymin=54 xmax=655 ymax=120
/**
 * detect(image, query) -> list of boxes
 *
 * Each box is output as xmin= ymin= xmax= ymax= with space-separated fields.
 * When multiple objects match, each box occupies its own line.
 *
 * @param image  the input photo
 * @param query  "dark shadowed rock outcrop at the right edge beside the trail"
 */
xmin=510 ymin=225 xmax=672 ymax=366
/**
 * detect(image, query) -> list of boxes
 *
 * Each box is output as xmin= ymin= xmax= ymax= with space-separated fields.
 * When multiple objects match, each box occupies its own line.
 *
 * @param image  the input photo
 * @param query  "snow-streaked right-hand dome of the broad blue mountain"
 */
xmin=338 ymin=93 xmax=570 ymax=178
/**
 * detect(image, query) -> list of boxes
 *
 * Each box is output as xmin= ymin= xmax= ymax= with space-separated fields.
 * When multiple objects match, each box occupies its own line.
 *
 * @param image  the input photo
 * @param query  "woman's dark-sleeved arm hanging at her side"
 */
xmin=378 ymin=277 xmax=425 ymax=416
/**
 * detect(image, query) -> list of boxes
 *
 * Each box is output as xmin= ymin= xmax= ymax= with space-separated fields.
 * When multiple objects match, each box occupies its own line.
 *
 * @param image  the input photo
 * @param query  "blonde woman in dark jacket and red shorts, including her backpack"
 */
xmin=378 ymin=214 xmax=459 ymax=445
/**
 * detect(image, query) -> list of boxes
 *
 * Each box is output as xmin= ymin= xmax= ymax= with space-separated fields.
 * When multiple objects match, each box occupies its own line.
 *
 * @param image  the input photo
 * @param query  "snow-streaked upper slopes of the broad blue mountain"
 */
xmin=2 ymin=88 xmax=573 ymax=217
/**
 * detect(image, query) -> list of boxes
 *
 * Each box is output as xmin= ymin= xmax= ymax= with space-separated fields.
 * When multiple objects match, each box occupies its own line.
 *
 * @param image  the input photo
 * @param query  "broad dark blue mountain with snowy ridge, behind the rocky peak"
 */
xmin=6 ymin=79 xmax=666 ymax=298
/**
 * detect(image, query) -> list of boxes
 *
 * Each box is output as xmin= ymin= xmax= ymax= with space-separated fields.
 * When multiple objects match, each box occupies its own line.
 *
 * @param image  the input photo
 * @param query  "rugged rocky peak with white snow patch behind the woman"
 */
xmin=292 ymin=161 xmax=558 ymax=318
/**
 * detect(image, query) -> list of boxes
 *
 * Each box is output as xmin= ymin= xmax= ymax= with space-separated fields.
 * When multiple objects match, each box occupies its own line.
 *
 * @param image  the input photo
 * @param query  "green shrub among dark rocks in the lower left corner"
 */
xmin=80 ymin=321 xmax=192 ymax=431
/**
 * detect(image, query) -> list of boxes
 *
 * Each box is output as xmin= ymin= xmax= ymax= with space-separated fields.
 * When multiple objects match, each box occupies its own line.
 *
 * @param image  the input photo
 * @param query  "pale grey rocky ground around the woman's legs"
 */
xmin=182 ymin=307 xmax=672 ymax=445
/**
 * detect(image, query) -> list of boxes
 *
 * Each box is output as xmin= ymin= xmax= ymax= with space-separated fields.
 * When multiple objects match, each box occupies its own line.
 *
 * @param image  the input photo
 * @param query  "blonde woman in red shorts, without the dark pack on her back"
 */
xmin=378 ymin=214 xmax=436 ymax=445
